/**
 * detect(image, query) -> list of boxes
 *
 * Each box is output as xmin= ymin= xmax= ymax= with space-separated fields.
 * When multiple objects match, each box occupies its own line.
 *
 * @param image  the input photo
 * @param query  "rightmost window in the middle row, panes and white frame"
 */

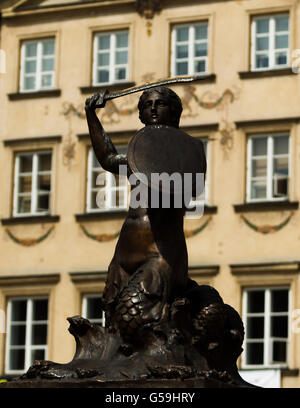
xmin=247 ymin=133 xmax=289 ymax=201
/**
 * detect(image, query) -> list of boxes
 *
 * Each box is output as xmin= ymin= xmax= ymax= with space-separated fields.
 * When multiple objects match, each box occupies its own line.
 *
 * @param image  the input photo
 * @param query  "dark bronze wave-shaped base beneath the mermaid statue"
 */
xmin=3 ymin=282 xmax=253 ymax=389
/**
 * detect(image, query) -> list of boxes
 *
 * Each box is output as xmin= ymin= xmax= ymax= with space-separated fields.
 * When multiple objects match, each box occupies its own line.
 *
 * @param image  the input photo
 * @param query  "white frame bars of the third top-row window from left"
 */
xmin=171 ymin=21 xmax=209 ymax=76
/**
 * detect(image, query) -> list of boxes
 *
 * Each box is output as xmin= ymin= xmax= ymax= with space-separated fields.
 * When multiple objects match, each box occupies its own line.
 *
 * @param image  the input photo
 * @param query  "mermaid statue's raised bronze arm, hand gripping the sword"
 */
xmin=85 ymin=90 xmax=127 ymax=174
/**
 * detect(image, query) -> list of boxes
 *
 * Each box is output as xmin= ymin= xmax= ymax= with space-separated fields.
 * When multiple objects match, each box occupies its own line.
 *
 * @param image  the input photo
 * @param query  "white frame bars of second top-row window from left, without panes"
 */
xmin=93 ymin=29 xmax=130 ymax=86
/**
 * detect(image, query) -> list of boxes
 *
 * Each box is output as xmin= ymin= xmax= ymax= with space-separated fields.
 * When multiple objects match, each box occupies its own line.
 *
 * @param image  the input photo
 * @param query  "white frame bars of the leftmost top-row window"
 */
xmin=19 ymin=36 xmax=56 ymax=93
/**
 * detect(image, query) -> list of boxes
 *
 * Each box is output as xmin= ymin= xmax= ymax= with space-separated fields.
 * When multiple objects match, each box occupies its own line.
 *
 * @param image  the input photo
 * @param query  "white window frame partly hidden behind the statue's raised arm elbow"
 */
xmin=86 ymin=147 xmax=129 ymax=213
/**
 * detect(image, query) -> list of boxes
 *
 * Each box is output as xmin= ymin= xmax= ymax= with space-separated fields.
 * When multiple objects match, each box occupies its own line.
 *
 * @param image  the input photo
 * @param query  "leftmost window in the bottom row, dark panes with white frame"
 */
xmin=6 ymin=297 xmax=48 ymax=374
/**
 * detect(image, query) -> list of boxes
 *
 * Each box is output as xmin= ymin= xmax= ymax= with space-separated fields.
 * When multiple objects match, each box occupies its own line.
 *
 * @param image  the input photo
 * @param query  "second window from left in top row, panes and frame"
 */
xmin=93 ymin=30 xmax=129 ymax=85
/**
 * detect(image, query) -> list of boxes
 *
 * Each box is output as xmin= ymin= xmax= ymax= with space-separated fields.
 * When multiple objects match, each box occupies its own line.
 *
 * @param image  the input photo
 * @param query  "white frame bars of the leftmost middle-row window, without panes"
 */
xmin=13 ymin=150 xmax=53 ymax=217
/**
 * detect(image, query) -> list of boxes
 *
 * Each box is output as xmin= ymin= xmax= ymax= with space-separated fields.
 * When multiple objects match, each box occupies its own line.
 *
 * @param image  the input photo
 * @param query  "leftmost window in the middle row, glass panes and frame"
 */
xmin=13 ymin=151 xmax=52 ymax=216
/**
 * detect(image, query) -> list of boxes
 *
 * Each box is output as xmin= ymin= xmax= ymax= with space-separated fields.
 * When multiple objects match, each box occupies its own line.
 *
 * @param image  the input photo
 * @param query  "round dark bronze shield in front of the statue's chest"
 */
xmin=127 ymin=125 xmax=206 ymax=193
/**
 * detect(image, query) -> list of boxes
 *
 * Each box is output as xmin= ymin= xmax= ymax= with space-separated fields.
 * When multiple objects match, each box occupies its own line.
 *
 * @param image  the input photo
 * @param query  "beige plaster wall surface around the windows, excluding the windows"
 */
xmin=0 ymin=0 xmax=300 ymax=387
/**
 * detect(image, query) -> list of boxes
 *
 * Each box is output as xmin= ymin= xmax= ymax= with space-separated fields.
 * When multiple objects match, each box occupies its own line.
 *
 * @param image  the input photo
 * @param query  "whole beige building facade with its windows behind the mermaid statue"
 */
xmin=0 ymin=0 xmax=300 ymax=387
